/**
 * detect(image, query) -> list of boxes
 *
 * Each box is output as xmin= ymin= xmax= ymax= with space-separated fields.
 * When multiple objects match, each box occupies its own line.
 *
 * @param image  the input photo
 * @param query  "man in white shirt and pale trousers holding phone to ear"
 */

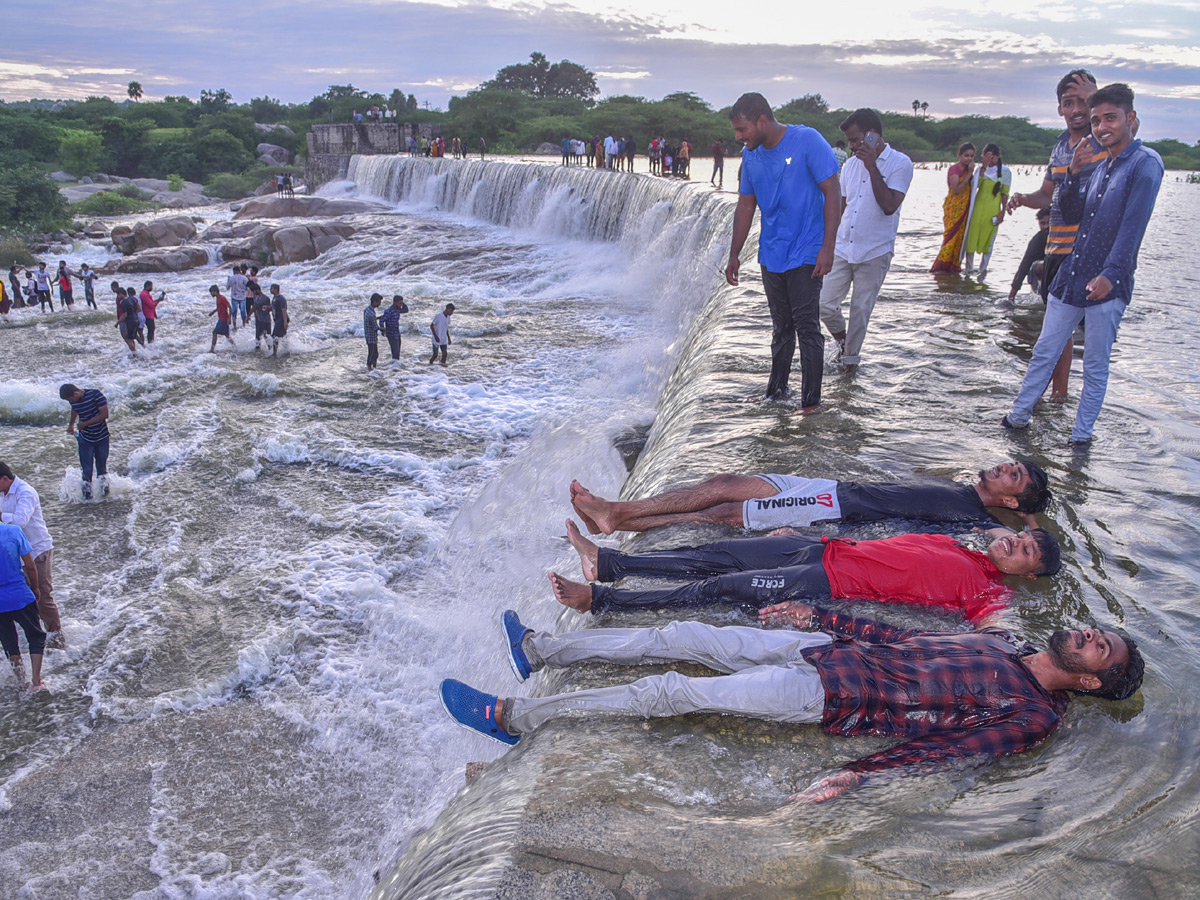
xmin=821 ymin=109 xmax=912 ymax=374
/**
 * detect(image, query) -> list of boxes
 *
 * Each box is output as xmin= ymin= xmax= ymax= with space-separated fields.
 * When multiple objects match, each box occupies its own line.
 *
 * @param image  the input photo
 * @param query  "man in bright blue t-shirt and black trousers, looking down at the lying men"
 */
xmin=725 ymin=94 xmax=841 ymax=414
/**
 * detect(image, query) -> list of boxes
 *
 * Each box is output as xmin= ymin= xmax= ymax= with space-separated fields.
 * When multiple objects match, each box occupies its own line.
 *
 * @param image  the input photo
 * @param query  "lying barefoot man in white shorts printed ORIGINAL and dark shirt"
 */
xmin=571 ymin=462 xmax=1050 ymax=534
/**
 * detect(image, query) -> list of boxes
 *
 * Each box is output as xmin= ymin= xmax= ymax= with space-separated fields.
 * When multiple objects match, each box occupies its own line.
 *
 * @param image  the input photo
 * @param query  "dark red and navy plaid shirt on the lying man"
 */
xmin=803 ymin=607 xmax=1069 ymax=775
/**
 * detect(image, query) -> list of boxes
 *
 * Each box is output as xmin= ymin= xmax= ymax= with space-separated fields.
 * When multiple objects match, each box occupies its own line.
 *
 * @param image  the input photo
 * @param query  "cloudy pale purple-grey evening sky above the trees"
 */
xmin=0 ymin=0 xmax=1200 ymax=144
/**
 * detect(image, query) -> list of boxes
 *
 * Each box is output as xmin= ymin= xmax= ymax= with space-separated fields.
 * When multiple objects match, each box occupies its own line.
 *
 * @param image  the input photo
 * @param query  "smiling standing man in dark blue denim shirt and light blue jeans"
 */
xmin=1001 ymin=84 xmax=1163 ymax=446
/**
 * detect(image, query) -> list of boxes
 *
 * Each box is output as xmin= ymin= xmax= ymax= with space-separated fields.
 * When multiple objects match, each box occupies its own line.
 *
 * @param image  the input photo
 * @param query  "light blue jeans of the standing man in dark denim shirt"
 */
xmin=1008 ymin=294 xmax=1126 ymax=440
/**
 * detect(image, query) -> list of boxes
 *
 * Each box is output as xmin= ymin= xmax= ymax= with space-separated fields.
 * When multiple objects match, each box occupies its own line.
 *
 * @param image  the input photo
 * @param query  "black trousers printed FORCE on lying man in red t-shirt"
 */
xmin=592 ymin=535 xmax=832 ymax=613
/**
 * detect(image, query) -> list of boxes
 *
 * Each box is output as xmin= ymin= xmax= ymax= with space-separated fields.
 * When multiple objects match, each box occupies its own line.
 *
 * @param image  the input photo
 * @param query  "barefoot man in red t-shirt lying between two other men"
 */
xmin=550 ymin=520 xmax=1061 ymax=622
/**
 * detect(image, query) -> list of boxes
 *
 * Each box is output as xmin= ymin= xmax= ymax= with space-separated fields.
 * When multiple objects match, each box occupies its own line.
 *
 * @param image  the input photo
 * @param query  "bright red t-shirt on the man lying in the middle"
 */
xmin=821 ymin=534 xmax=1012 ymax=622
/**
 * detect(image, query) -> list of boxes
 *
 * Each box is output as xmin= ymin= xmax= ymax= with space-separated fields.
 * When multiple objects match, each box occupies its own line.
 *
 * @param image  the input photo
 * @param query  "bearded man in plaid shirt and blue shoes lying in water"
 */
xmin=442 ymin=604 xmax=1144 ymax=802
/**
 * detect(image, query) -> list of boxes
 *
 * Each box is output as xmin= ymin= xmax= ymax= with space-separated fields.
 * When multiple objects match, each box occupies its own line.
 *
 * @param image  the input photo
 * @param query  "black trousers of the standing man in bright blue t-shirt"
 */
xmin=762 ymin=264 xmax=824 ymax=407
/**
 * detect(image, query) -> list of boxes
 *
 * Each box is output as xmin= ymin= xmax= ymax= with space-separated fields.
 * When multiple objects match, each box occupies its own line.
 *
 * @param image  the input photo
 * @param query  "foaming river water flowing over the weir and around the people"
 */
xmin=0 ymin=157 xmax=1200 ymax=899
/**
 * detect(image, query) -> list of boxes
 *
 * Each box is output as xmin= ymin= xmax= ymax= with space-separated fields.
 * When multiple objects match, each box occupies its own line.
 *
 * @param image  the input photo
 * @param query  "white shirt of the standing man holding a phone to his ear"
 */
xmin=834 ymin=144 xmax=912 ymax=265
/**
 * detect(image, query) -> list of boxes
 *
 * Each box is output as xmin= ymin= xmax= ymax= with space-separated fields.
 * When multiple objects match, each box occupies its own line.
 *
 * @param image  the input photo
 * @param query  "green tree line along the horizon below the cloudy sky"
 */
xmin=0 ymin=53 xmax=1200 ymax=240
